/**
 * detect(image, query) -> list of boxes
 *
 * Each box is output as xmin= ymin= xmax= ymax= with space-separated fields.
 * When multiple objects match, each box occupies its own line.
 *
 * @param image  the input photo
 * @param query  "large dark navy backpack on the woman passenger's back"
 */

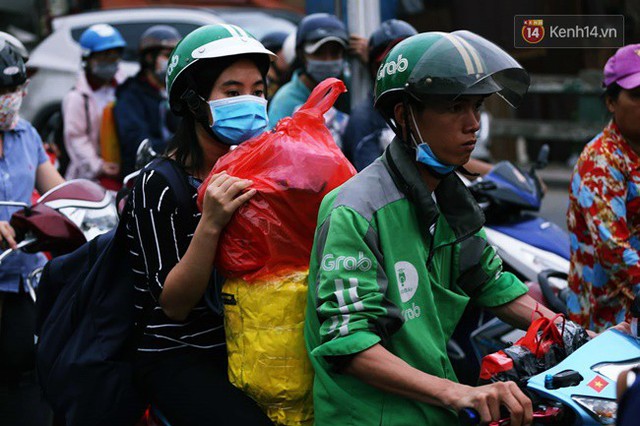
xmin=36 ymin=159 xmax=192 ymax=426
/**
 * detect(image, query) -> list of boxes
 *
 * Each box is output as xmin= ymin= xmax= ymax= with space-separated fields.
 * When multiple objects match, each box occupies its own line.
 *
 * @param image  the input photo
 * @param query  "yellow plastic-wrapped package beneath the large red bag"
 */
xmin=222 ymin=270 xmax=313 ymax=425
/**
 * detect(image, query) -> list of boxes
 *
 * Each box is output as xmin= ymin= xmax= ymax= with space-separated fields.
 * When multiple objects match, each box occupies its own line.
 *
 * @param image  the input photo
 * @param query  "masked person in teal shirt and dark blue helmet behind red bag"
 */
xmin=269 ymin=13 xmax=349 ymax=147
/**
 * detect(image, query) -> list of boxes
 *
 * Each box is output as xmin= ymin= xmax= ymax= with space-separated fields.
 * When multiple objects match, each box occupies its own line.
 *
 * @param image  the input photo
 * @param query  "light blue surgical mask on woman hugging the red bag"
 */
xmin=208 ymin=95 xmax=269 ymax=145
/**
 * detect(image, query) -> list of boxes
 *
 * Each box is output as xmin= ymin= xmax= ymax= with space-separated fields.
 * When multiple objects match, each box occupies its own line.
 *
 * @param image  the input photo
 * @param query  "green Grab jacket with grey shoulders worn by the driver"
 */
xmin=305 ymin=139 xmax=527 ymax=426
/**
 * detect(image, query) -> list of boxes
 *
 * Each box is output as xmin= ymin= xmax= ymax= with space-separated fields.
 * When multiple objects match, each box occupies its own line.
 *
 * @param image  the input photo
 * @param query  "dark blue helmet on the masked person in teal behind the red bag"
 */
xmin=296 ymin=13 xmax=349 ymax=53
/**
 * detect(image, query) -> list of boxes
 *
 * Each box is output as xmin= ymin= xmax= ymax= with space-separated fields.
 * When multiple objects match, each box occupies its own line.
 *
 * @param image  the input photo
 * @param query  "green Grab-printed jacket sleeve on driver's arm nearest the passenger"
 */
xmin=310 ymin=207 xmax=402 ymax=356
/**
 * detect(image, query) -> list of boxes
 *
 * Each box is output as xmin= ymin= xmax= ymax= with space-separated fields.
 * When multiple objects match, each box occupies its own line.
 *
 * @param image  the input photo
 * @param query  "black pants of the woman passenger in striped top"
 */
xmin=136 ymin=347 xmax=272 ymax=426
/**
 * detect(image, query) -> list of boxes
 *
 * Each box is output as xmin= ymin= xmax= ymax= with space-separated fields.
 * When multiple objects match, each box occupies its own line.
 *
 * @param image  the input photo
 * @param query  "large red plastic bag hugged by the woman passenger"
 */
xmin=198 ymin=78 xmax=356 ymax=281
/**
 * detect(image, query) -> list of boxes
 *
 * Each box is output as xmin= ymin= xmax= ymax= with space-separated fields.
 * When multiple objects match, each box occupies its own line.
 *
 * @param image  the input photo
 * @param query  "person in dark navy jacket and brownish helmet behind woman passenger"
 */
xmin=114 ymin=25 xmax=181 ymax=176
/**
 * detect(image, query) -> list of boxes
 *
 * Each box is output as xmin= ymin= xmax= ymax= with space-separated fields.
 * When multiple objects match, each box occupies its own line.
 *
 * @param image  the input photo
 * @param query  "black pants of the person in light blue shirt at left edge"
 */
xmin=0 ymin=293 xmax=52 ymax=426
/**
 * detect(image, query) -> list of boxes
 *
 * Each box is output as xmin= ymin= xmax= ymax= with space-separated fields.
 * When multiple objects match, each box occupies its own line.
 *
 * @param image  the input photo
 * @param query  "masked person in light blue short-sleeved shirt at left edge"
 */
xmin=0 ymin=38 xmax=63 ymax=426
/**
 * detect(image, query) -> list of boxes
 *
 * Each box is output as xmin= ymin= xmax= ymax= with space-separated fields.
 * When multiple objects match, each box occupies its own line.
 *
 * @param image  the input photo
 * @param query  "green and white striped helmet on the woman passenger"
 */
xmin=166 ymin=24 xmax=277 ymax=112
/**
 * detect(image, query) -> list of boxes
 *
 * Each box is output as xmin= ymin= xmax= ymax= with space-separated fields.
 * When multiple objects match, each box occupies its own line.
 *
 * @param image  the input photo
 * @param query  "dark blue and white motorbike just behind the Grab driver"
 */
xmin=448 ymin=145 xmax=570 ymax=384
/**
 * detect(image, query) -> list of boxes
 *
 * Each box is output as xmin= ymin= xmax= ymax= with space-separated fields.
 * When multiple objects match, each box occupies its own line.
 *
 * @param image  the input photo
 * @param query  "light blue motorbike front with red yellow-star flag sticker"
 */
xmin=460 ymin=297 xmax=640 ymax=426
